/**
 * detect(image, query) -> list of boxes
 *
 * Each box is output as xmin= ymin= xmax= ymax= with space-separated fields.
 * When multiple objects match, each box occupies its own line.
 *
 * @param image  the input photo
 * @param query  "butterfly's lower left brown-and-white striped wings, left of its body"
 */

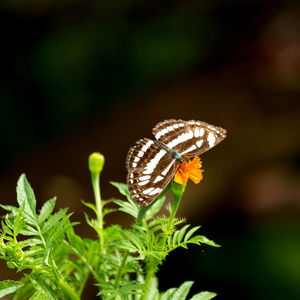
xmin=126 ymin=138 xmax=177 ymax=206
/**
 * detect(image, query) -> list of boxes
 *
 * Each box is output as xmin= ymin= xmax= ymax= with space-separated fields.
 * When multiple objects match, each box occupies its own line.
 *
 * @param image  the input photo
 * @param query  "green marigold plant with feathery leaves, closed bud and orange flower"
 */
xmin=0 ymin=153 xmax=218 ymax=300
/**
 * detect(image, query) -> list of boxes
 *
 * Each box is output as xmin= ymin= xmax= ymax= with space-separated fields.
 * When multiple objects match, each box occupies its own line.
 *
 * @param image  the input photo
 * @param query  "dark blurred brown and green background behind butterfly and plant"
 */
xmin=0 ymin=0 xmax=300 ymax=300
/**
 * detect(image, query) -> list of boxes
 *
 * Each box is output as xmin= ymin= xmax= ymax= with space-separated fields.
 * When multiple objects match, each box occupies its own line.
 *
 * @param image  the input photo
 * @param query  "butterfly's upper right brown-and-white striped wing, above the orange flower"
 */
xmin=152 ymin=119 xmax=226 ymax=158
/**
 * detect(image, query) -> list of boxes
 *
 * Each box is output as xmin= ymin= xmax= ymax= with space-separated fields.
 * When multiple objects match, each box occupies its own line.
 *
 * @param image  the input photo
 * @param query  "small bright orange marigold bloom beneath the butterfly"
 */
xmin=174 ymin=156 xmax=203 ymax=184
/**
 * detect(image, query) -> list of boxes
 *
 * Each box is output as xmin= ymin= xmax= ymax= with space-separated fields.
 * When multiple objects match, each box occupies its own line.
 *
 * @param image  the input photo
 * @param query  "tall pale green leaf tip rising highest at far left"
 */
xmin=17 ymin=174 xmax=36 ymax=222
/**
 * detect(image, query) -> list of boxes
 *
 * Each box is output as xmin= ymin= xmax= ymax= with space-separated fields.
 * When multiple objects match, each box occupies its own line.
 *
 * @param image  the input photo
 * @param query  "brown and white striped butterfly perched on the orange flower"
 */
xmin=126 ymin=119 xmax=226 ymax=206
